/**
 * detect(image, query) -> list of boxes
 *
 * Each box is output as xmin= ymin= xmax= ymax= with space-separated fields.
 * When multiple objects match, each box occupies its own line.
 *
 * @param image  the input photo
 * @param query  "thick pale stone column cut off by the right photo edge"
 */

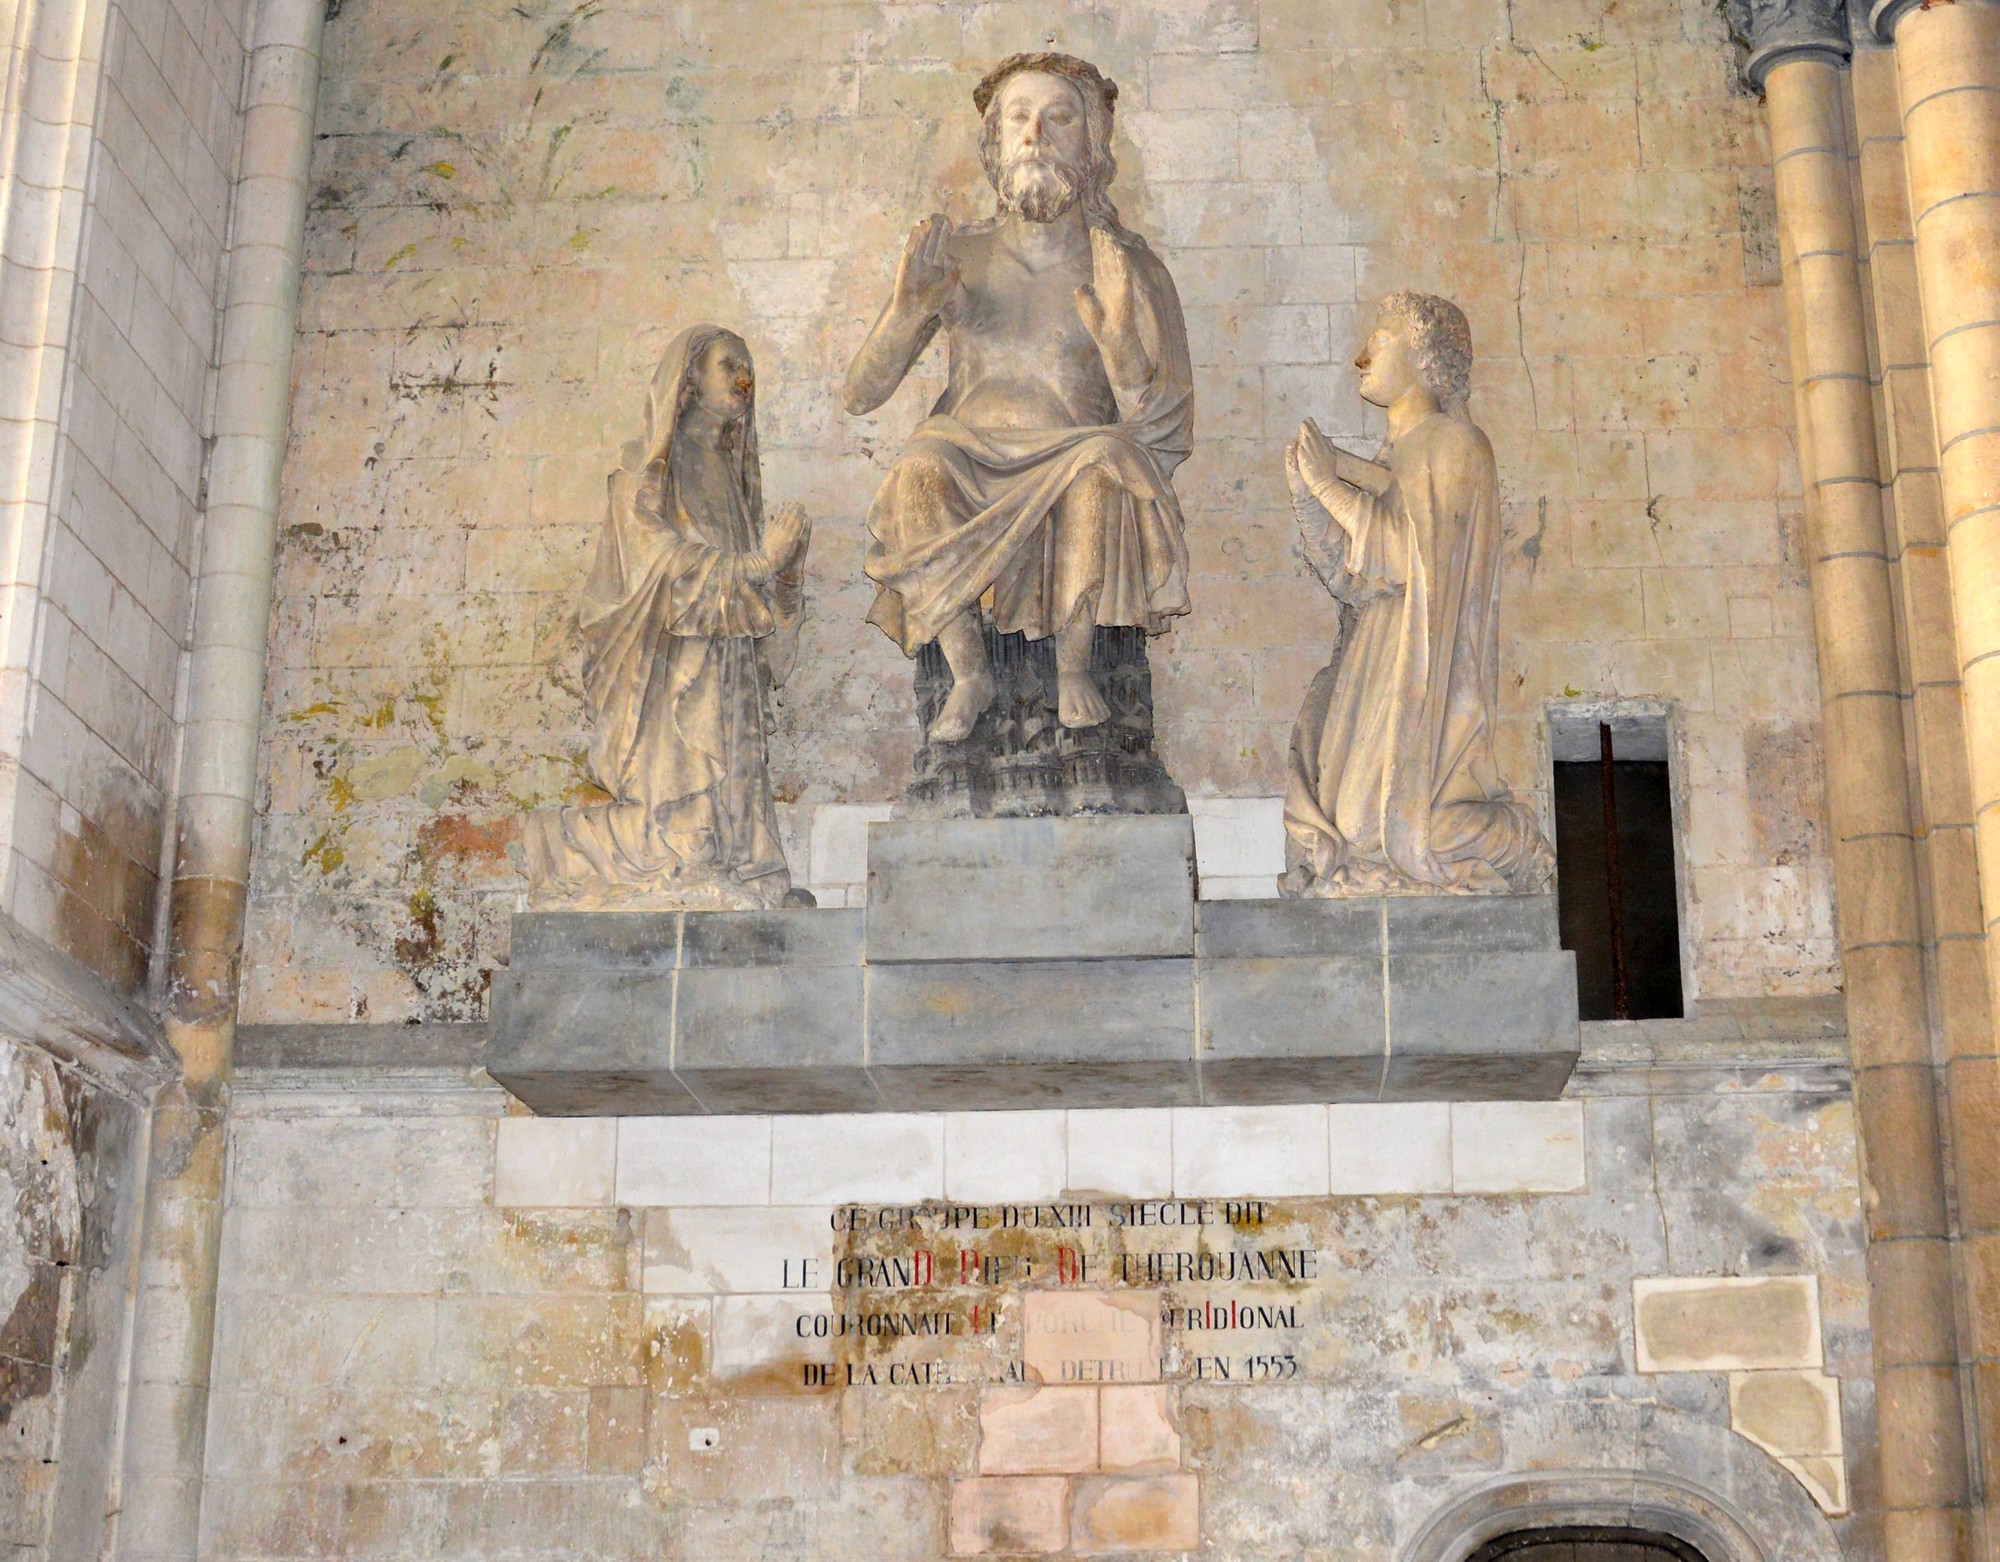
xmin=1870 ymin=0 xmax=2000 ymax=1556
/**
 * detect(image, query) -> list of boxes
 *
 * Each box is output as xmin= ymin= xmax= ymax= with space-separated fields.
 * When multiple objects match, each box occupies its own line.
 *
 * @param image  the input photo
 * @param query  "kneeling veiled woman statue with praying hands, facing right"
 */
xmin=528 ymin=326 xmax=810 ymax=910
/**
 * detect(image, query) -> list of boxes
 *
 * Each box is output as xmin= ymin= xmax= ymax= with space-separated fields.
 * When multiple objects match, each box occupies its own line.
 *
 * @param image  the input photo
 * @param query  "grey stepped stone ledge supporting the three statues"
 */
xmin=486 ymin=816 xmax=1578 ymax=1116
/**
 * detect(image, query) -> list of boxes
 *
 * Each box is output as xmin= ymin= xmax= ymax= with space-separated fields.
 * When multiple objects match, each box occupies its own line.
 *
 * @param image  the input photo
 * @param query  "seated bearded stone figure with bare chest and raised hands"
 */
xmin=846 ymin=54 xmax=1194 ymax=742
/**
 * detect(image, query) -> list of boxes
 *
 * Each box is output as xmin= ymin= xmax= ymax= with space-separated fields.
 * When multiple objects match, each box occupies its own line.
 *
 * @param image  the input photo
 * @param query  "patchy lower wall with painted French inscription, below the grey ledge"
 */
xmin=204 ymin=1060 xmax=1878 ymax=1562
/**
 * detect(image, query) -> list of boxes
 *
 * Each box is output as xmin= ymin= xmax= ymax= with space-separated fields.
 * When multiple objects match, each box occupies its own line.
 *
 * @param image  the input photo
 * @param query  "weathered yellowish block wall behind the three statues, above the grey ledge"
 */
xmin=244 ymin=0 xmax=1834 ymax=1022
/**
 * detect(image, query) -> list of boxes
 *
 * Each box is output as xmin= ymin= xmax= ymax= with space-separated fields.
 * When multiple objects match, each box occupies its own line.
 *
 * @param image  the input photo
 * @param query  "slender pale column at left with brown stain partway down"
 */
xmin=116 ymin=0 xmax=326 ymax=1562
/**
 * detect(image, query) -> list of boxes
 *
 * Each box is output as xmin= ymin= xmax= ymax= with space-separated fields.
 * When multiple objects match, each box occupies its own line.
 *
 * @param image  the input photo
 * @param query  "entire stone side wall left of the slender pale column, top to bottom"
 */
xmin=0 ymin=0 xmax=246 ymax=1558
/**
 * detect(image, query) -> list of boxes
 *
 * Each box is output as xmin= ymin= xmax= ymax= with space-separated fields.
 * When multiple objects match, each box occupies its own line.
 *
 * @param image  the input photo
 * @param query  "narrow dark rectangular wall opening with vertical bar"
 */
xmin=1548 ymin=706 xmax=1682 ymax=1020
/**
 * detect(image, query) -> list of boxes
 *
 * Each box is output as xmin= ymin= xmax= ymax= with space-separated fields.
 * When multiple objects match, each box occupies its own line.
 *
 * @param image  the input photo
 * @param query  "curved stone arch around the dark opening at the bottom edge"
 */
xmin=1402 ymin=1470 xmax=1768 ymax=1562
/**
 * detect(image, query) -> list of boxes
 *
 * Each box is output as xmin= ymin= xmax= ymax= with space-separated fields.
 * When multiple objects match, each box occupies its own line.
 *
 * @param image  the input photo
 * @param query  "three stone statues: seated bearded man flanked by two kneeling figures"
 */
xmin=528 ymin=54 xmax=1552 ymax=910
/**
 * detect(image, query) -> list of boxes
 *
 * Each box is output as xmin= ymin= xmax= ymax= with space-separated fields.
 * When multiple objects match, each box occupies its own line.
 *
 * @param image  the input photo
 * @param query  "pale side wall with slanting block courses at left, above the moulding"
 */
xmin=0 ymin=0 xmax=246 ymax=992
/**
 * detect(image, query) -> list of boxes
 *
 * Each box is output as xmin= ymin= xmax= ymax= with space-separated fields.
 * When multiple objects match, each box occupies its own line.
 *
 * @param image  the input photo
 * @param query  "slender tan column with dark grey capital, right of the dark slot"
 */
xmin=1748 ymin=0 xmax=1968 ymax=1562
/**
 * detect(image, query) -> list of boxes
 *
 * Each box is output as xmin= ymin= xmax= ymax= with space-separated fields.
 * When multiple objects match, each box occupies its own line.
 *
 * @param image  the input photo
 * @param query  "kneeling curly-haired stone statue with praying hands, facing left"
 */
xmin=1280 ymin=292 xmax=1554 ymax=896
